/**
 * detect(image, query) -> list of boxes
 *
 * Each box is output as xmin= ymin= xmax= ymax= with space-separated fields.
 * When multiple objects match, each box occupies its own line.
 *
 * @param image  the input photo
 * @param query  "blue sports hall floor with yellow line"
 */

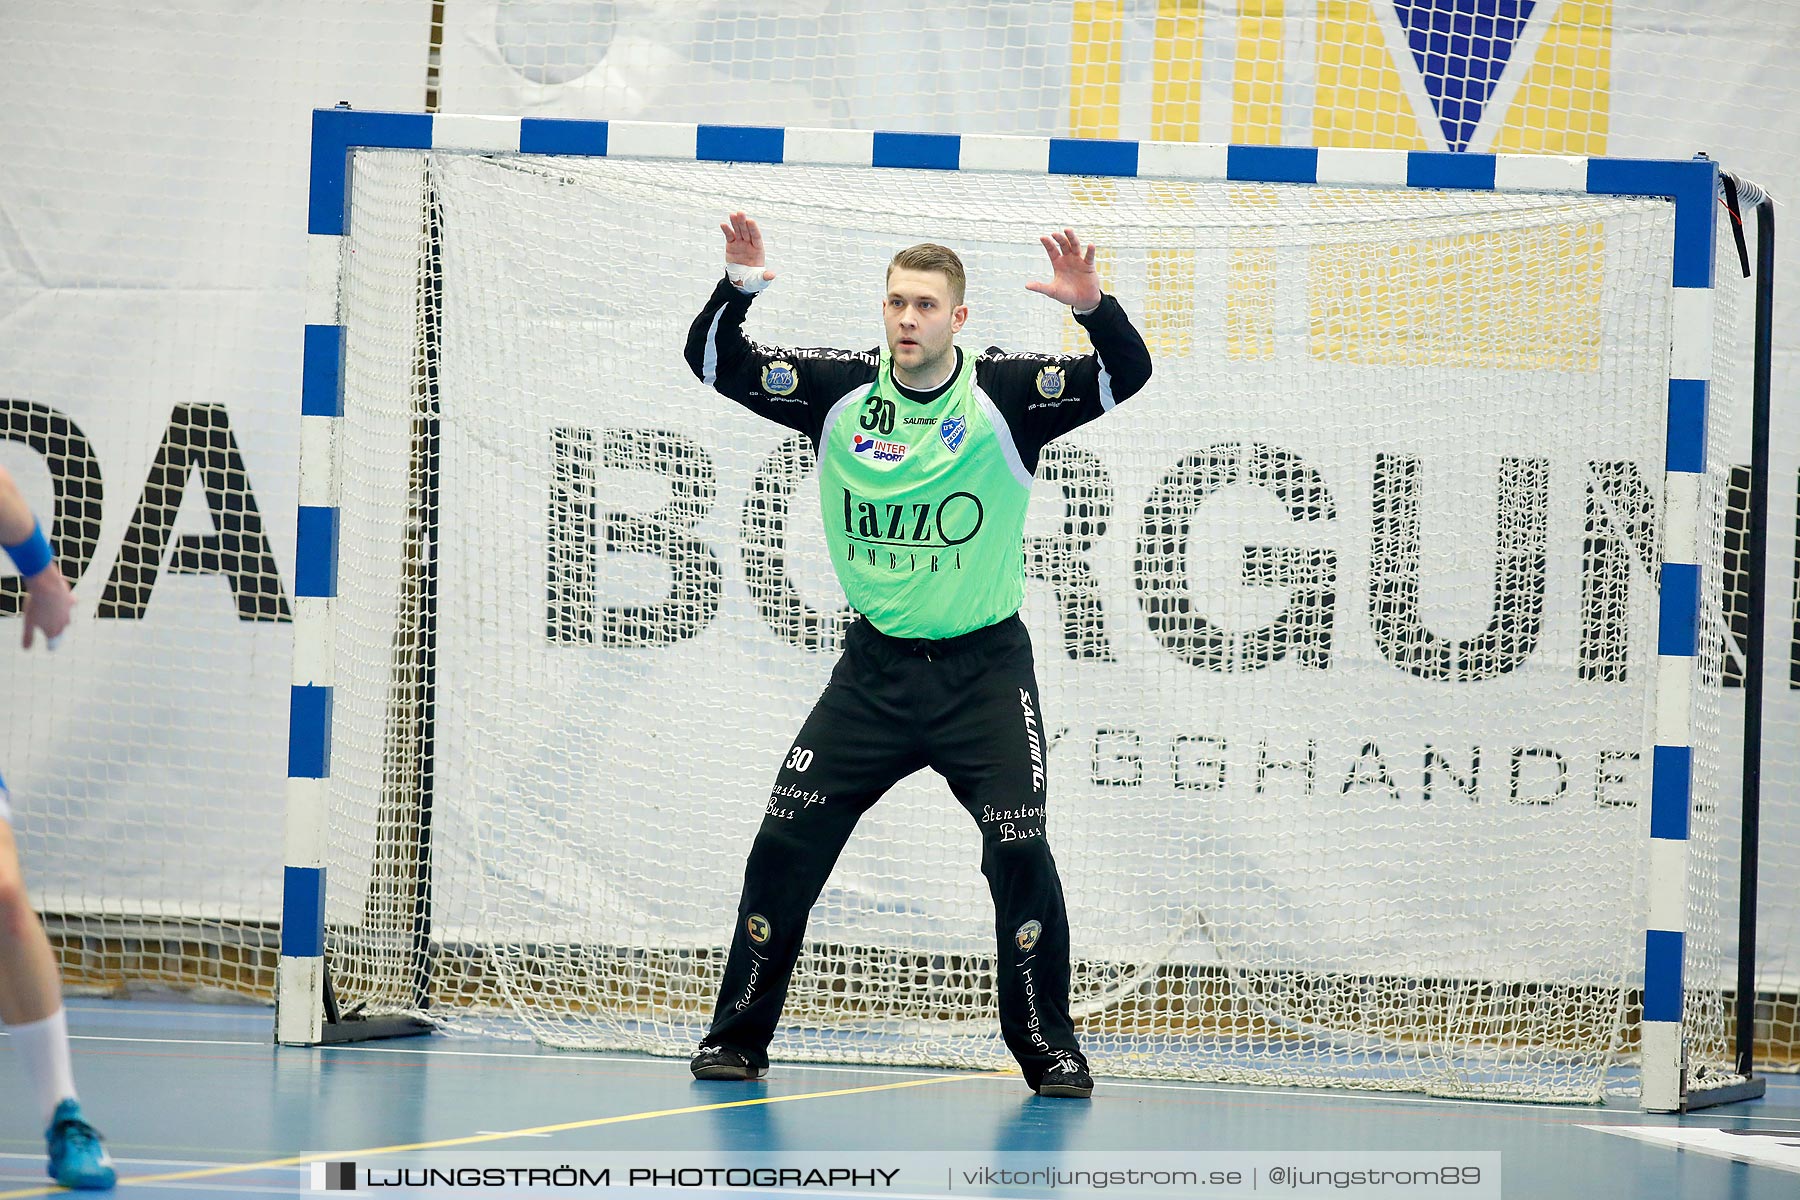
xmin=0 ymin=999 xmax=1800 ymax=1200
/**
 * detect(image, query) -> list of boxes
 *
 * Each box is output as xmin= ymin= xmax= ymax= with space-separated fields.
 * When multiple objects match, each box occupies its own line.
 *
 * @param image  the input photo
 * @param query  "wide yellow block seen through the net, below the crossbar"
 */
xmin=1307 ymin=223 xmax=1602 ymax=371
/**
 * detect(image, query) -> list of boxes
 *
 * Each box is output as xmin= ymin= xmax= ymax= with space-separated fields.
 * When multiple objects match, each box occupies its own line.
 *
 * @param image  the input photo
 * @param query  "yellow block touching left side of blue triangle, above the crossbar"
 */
xmin=1312 ymin=0 xmax=1426 ymax=149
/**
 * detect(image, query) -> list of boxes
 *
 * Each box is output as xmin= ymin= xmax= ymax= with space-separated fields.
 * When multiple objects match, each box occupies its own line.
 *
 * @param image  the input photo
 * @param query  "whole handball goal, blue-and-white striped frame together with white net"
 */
xmin=288 ymin=108 xmax=1760 ymax=1110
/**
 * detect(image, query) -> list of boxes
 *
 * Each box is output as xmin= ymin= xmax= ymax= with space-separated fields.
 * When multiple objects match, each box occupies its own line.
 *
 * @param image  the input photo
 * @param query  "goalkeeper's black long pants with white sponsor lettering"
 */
xmin=706 ymin=615 xmax=1080 ymax=1087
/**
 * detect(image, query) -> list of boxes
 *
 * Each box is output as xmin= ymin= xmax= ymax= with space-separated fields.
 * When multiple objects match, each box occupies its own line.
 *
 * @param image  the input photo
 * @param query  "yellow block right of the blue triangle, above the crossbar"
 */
xmin=1489 ymin=0 xmax=1613 ymax=155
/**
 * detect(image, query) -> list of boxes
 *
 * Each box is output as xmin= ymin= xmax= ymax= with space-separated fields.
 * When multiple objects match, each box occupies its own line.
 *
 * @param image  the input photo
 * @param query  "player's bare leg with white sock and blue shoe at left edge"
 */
xmin=0 ymin=781 xmax=113 ymax=1187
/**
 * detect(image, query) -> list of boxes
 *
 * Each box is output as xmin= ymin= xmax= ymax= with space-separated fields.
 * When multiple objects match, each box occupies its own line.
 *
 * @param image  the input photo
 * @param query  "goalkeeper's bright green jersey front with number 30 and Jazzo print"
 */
xmin=819 ymin=353 xmax=1031 ymax=639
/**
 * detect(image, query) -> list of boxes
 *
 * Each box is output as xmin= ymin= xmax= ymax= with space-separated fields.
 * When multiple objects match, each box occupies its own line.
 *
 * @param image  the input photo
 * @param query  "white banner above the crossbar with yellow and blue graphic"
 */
xmin=428 ymin=0 xmax=1800 ymax=988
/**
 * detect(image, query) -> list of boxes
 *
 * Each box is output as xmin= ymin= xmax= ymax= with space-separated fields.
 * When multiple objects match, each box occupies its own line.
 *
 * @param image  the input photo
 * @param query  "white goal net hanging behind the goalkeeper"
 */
xmin=309 ymin=143 xmax=1748 ymax=1099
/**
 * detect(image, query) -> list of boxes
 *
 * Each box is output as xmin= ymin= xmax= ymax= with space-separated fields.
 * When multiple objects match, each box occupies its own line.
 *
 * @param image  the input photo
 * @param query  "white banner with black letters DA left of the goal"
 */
xmin=0 ymin=0 xmax=430 ymax=923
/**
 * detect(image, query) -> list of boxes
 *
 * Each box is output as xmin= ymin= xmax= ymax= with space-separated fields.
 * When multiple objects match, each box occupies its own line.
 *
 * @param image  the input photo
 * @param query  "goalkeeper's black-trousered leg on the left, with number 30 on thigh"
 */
xmin=691 ymin=637 xmax=925 ymax=1079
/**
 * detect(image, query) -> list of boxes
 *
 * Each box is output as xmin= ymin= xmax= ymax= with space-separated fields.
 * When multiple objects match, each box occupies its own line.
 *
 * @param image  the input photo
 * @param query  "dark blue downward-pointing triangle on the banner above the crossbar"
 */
xmin=1393 ymin=0 xmax=1537 ymax=149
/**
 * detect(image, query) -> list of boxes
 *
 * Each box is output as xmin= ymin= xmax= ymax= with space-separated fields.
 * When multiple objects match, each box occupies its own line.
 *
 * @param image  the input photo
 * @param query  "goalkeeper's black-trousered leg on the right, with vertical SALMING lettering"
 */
xmin=931 ymin=622 xmax=1094 ymax=1097
